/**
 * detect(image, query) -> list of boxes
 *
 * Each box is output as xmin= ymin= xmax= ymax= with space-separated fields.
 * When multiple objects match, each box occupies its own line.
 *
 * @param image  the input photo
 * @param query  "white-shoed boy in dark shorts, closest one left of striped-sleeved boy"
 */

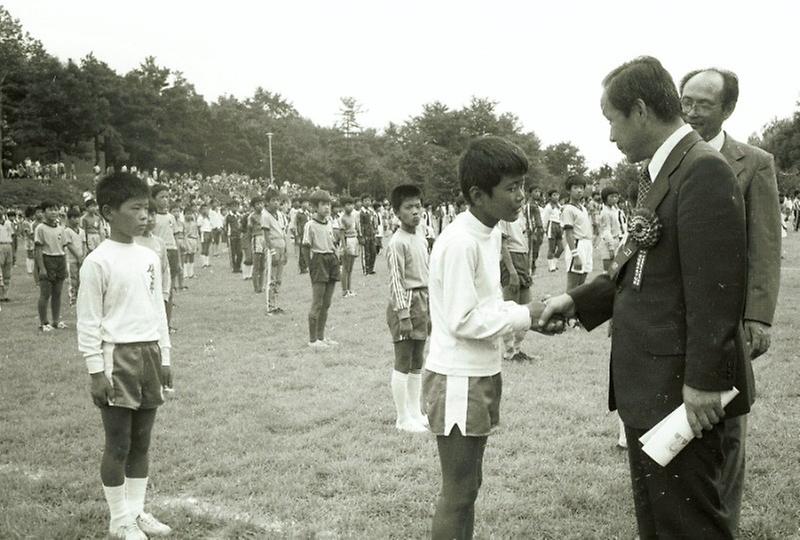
xmin=303 ymin=189 xmax=340 ymax=351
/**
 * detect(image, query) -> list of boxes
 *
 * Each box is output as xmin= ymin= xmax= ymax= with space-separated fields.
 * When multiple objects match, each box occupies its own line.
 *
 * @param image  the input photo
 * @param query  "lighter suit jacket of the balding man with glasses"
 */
xmin=721 ymin=133 xmax=781 ymax=324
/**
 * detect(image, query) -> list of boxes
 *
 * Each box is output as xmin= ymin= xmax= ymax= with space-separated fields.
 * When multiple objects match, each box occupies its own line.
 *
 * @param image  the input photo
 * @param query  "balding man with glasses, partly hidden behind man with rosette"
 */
xmin=680 ymin=68 xmax=781 ymax=531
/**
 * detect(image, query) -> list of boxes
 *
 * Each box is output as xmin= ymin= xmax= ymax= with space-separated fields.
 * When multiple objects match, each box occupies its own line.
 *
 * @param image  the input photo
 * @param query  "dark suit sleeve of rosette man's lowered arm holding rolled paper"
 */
xmin=677 ymin=157 xmax=747 ymax=391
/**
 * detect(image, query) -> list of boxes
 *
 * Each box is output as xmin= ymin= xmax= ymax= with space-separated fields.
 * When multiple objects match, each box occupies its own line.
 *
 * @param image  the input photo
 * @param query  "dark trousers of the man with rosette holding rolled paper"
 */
xmin=625 ymin=420 xmax=734 ymax=540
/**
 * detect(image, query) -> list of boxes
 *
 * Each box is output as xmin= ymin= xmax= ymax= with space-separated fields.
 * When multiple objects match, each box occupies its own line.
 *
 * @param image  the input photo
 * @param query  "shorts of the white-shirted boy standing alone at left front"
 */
xmin=103 ymin=341 xmax=164 ymax=409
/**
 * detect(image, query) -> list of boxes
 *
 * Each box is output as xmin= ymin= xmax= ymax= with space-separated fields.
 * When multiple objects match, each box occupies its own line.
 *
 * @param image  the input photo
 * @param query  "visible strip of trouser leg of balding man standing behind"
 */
xmin=722 ymin=415 xmax=747 ymax=533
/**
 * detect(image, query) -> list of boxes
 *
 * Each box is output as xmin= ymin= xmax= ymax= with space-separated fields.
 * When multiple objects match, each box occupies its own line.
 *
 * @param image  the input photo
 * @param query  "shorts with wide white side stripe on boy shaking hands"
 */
xmin=422 ymin=369 xmax=503 ymax=437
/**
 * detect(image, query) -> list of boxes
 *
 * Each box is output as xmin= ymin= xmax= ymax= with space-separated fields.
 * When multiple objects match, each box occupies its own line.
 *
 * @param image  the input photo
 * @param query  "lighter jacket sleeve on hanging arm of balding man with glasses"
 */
xmin=744 ymin=152 xmax=781 ymax=324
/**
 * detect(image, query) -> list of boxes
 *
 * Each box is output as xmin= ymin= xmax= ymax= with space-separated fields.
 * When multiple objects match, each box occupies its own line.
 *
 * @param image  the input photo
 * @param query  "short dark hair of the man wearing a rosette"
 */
xmin=603 ymin=56 xmax=681 ymax=122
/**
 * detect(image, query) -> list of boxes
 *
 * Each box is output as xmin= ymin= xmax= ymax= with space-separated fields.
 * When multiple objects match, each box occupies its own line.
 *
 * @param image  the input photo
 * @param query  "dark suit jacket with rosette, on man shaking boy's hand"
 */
xmin=570 ymin=132 xmax=754 ymax=429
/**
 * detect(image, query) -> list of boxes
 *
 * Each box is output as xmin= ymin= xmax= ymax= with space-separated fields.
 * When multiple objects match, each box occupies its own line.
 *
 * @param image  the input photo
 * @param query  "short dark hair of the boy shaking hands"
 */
xmin=458 ymin=136 xmax=528 ymax=204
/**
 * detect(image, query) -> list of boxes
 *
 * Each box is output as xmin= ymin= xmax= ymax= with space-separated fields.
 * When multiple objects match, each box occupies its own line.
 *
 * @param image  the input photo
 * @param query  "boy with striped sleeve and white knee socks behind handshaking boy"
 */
xmin=386 ymin=184 xmax=430 ymax=433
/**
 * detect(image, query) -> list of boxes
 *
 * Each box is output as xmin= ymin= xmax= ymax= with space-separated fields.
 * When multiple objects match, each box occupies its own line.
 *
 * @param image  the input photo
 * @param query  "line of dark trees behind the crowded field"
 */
xmin=0 ymin=6 xmax=800 ymax=201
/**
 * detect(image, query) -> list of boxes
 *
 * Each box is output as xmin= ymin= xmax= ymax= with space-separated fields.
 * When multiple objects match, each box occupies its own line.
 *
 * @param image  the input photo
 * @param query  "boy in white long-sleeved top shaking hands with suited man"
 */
xmin=423 ymin=137 xmax=563 ymax=540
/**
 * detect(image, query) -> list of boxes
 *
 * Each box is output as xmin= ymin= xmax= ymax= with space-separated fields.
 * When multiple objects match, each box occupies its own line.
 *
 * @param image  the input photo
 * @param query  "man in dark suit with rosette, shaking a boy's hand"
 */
xmin=540 ymin=57 xmax=754 ymax=539
